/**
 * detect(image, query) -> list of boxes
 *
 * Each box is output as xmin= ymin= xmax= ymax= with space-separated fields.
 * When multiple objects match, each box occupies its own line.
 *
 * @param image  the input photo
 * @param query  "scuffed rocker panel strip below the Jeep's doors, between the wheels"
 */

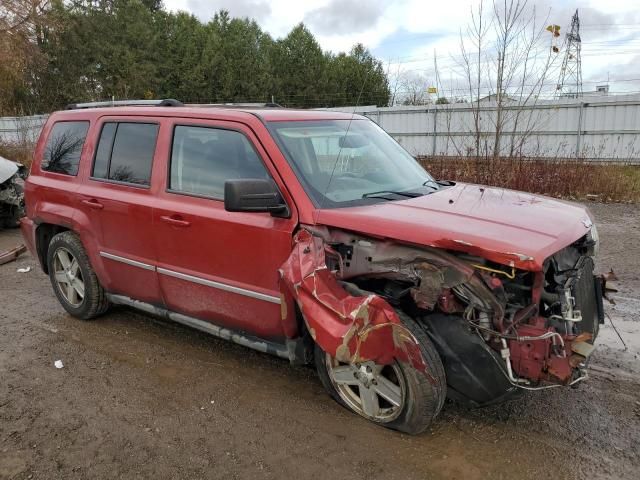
xmin=107 ymin=293 xmax=301 ymax=364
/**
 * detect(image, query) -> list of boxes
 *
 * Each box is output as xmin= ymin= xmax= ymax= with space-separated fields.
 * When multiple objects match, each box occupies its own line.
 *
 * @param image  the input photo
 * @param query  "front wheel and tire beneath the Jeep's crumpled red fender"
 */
xmin=315 ymin=312 xmax=447 ymax=435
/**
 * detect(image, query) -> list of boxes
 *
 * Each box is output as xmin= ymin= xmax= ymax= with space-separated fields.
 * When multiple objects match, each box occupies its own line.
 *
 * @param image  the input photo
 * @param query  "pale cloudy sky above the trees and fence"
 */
xmin=164 ymin=0 xmax=640 ymax=97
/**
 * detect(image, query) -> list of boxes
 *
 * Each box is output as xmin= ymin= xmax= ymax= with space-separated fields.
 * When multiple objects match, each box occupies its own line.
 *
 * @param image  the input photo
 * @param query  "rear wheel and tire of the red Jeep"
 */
xmin=47 ymin=231 xmax=109 ymax=320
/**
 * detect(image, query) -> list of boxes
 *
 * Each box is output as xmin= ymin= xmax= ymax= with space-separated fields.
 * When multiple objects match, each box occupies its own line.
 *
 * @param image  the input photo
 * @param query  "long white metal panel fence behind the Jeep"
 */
xmin=0 ymin=95 xmax=640 ymax=163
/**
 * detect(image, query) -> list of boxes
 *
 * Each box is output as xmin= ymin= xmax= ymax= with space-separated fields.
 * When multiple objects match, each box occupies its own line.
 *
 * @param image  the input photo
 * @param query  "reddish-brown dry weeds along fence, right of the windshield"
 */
xmin=419 ymin=157 xmax=640 ymax=203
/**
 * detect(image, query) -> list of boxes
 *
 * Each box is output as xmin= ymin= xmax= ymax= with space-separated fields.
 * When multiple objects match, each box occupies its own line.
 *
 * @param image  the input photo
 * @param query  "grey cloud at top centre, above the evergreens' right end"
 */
xmin=304 ymin=0 xmax=386 ymax=35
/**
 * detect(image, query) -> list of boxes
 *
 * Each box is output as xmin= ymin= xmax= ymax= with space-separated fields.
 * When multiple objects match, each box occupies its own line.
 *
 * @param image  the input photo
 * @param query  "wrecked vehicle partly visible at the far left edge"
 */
xmin=0 ymin=157 xmax=27 ymax=228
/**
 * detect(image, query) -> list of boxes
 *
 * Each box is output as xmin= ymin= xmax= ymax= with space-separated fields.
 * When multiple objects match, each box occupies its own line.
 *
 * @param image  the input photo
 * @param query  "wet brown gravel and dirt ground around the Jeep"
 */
xmin=0 ymin=204 xmax=640 ymax=479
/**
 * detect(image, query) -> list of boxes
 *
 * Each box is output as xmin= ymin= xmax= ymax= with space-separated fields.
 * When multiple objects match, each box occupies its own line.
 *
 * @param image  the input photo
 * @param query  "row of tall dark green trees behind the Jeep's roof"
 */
xmin=0 ymin=0 xmax=389 ymax=115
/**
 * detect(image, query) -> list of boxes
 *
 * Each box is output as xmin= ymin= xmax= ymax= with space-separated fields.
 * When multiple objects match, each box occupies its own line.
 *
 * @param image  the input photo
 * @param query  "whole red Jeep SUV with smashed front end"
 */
xmin=21 ymin=100 xmax=604 ymax=433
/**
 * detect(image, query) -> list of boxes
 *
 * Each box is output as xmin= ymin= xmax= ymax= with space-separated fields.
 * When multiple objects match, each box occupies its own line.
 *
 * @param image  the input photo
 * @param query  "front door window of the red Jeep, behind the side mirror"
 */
xmin=169 ymin=125 xmax=270 ymax=199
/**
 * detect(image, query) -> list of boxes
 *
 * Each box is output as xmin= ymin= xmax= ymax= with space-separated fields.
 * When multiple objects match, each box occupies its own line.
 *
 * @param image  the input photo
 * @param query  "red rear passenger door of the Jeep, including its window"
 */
xmin=77 ymin=117 xmax=162 ymax=305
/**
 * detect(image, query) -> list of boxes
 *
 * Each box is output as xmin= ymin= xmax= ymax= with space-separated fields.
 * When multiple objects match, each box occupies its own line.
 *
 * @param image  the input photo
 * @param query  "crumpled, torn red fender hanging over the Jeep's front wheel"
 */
xmin=280 ymin=230 xmax=426 ymax=373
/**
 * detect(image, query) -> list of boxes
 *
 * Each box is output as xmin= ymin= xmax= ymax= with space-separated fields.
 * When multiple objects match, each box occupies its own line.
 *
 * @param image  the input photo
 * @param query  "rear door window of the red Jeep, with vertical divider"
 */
xmin=91 ymin=122 xmax=158 ymax=185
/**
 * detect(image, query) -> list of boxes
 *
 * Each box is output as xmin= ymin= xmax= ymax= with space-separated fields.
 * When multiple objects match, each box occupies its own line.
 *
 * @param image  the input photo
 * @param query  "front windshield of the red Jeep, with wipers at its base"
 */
xmin=269 ymin=119 xmax=438 ymax=208
